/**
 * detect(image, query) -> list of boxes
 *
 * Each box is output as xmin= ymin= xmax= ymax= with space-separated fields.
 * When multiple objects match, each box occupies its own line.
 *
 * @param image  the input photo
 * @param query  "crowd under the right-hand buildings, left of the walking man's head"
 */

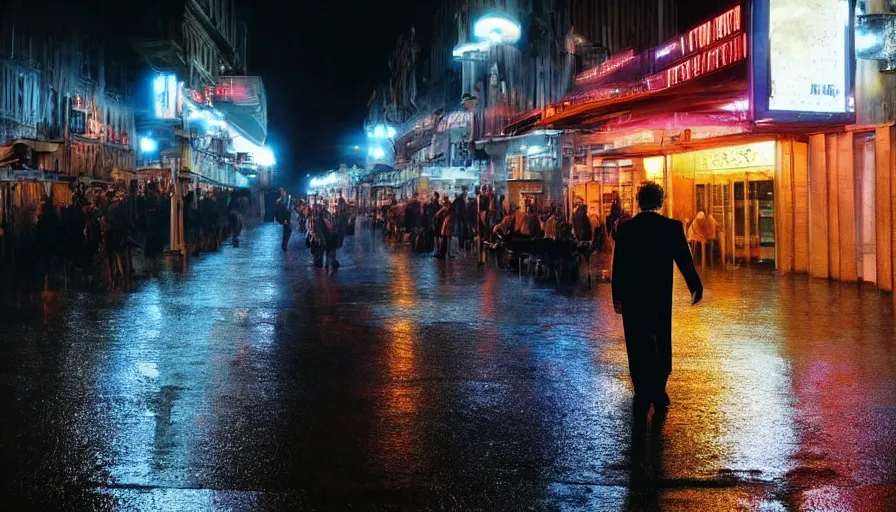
xmin=377 ymin=185 xmax=629 ymax=280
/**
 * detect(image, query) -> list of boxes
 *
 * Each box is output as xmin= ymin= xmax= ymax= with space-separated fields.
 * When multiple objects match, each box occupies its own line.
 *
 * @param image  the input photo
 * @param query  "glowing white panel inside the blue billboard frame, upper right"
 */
xmin=768 ymin=0 xmax=849 ymax=113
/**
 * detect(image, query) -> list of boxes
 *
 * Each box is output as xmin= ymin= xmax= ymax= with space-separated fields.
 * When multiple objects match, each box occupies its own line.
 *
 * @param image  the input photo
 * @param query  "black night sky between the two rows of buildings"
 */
xmin=245 ymin=0 xmax=437 ymax=187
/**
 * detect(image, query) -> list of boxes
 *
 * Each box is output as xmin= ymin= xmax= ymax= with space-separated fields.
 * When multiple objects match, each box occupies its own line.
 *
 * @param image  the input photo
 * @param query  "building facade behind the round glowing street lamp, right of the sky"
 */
xmin=366 ymin=0 xmax=677 ymax=212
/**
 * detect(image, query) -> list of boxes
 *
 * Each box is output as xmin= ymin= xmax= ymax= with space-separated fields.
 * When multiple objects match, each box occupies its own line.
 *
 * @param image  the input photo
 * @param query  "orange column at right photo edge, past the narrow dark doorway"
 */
xmin=874 ymin=126 xmax=896 ymax=291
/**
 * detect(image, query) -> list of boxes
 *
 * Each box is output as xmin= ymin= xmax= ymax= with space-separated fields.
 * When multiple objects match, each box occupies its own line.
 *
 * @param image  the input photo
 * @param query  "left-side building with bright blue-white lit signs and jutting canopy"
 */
xmin=130 ymin=0 xmax=275 ymax=249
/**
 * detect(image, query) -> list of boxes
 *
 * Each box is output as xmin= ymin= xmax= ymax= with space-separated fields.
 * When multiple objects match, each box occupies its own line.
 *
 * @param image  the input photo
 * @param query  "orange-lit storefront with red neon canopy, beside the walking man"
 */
xmin=520 ymin=0 xmax=896 ymax=290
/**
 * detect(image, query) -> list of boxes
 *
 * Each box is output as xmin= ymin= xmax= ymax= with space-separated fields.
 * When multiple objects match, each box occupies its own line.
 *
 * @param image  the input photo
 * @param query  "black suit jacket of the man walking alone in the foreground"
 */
xmin=613 ymin=212 xmax=703 ymax=314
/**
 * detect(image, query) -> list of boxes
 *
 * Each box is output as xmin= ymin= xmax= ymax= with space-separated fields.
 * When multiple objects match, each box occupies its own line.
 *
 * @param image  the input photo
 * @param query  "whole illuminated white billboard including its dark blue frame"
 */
xmin=752 ymin=0 xmax=854 ymax=121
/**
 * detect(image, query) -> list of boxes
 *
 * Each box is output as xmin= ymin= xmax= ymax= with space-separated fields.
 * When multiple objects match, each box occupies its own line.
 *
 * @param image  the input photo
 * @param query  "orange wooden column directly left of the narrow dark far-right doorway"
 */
xmin=837 ymin=132 xmax=859 ymax=281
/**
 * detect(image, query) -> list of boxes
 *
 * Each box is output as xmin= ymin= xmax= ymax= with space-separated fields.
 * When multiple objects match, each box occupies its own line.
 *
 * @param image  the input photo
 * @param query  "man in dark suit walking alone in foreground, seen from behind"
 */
xmin=613 ymin=182 xmax=703 ymax=408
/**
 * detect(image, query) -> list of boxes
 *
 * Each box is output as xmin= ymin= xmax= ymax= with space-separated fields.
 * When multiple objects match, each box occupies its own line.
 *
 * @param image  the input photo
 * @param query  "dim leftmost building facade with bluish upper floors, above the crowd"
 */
xmin=0 ymin=3 xmax=135 ymax=224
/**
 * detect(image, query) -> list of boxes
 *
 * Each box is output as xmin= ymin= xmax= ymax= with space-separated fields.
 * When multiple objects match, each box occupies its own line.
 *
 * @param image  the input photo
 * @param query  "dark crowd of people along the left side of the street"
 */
xmin=0 ymin=181 xmax=248 ymax=304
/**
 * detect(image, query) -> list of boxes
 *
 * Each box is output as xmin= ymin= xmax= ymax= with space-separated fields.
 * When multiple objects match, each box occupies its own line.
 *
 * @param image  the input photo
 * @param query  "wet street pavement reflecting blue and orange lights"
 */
xmin=0 ymin=225 xmax=896 ymax=511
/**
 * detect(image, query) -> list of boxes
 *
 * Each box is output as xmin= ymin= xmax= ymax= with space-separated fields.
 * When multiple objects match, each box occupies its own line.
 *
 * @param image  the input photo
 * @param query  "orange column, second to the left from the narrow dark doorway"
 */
xmin=809 ymin=134 xmax=830 ymax=279
